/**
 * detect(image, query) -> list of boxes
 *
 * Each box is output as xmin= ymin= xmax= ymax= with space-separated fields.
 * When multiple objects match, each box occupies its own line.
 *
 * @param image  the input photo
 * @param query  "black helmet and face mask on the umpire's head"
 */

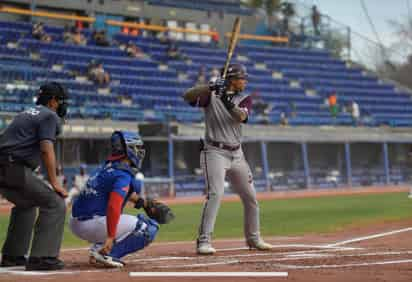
xmin=36 ymin=82 xmax=69 ymax=118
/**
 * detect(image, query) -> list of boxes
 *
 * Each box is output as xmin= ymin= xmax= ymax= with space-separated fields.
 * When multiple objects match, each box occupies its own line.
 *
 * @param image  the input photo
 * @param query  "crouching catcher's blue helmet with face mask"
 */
xmin=110 ymin=131 xmax=146 ymax=169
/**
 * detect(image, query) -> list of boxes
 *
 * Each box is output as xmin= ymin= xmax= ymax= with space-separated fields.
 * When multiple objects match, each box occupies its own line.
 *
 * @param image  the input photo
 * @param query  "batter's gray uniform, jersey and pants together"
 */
xmin=189 ymin=87 xmax=260 ymax=246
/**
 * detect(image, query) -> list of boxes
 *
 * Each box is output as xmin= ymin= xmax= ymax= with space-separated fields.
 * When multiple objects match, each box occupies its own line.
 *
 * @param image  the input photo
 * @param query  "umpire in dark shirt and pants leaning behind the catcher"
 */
xmin=0 ymin=82 xmax=68 ymax=270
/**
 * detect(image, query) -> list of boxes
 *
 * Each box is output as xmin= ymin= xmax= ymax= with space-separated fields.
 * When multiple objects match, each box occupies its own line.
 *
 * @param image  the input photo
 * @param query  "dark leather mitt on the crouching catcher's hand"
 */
xmin=134 ymin=198 xmax=175 ymax=224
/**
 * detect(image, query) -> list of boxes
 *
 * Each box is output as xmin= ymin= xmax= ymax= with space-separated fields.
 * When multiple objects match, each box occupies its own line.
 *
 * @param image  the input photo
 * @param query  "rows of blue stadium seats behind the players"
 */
xmin=0 ymin=19 xmax=412 ymax=126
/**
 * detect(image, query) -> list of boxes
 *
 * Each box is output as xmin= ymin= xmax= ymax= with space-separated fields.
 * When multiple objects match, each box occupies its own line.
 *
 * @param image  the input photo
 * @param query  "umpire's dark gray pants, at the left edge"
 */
xmin=0 ymin=163 xmax=66 ymax=257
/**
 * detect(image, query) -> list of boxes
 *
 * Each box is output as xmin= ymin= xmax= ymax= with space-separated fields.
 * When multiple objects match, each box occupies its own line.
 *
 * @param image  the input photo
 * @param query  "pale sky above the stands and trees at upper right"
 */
xmin=300 ymin=0 xmax=412 ymax=63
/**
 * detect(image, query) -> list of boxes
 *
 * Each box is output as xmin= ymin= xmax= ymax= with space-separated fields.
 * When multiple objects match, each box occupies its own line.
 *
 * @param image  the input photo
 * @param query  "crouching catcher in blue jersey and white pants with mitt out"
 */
xmin=69 ymin=131 xmax=174 ymax=268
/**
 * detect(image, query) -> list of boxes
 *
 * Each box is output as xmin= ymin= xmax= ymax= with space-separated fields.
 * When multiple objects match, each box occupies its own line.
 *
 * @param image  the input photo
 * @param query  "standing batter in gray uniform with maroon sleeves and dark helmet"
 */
xmin=183 ymin=64 xmax=272 ymax=255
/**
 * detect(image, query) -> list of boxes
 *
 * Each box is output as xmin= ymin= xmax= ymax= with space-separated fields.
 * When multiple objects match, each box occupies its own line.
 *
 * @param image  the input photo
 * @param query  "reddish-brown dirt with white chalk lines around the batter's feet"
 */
xmin=0 ymin=188 xmax=412 ymax=282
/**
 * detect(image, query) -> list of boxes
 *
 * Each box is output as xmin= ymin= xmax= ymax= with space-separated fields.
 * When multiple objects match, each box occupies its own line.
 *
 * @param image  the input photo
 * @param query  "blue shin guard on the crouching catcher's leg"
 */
xmin=109 ymin=214 xmax=159 ymax=258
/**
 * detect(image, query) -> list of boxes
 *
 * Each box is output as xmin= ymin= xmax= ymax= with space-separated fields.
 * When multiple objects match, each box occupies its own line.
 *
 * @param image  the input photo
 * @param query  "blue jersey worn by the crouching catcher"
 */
xmin=72 ymin=161 xmax=141 ymax=217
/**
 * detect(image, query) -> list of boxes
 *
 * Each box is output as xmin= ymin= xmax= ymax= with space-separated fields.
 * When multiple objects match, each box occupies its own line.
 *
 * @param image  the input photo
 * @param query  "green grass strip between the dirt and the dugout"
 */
xmin=0 ymin=193 xmax=412 ymax=247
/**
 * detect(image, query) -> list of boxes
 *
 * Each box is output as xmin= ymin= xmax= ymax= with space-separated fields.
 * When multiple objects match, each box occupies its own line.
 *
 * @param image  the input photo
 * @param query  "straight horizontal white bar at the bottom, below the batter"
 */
xmin=129 ymin=272 xmax=288 ymax=277
